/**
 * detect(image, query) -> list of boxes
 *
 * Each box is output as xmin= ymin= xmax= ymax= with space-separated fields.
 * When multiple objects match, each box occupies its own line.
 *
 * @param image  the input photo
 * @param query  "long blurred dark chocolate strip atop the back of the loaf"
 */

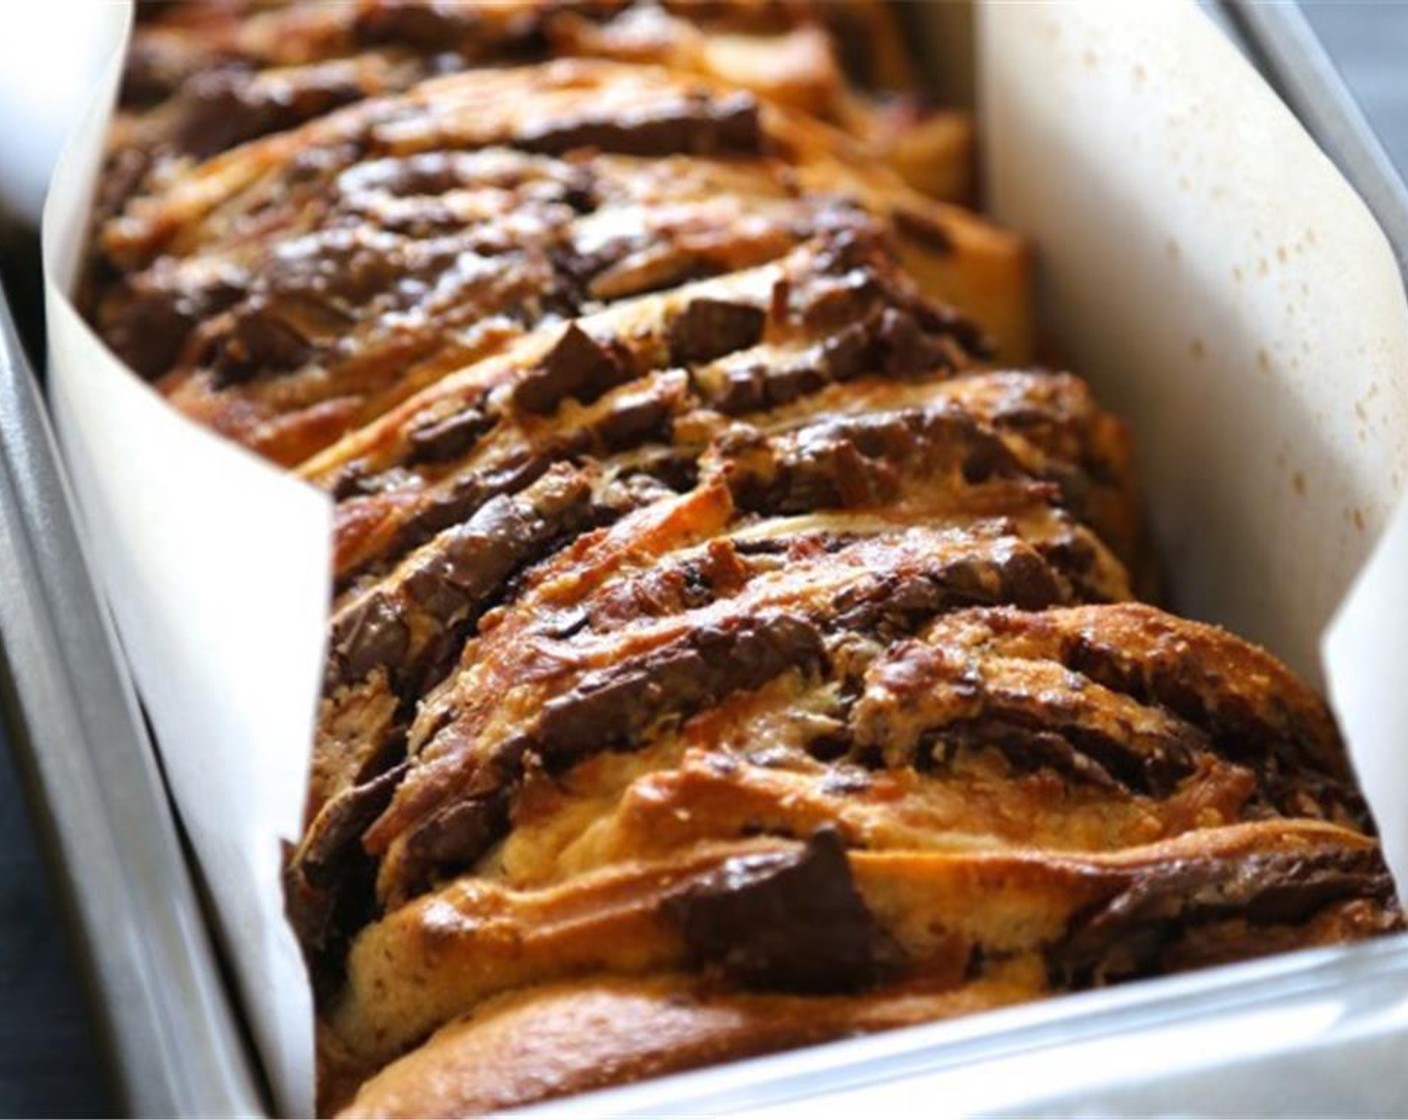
xmin=514 ymin=93 xmax=765 ymax=156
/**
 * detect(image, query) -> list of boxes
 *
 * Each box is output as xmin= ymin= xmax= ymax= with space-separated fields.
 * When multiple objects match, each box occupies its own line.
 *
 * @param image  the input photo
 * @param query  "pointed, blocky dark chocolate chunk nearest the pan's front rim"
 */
xmin=665 ymin=828 xmax=894 ymax=995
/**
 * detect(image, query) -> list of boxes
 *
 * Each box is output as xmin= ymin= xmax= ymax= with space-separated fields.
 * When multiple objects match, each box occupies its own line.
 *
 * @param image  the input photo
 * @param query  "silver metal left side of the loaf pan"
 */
xmin=0 ymin=283 xmax=265 ymax=1116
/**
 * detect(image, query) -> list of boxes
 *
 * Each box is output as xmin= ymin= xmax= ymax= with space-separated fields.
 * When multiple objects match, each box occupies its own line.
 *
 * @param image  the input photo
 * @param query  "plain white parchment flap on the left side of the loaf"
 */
xmin=44 ymin=10 xmax=332 ymax=1116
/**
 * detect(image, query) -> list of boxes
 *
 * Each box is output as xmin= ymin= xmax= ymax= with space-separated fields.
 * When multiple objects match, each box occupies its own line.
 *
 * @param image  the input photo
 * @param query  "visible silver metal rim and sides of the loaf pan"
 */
xmin=0 ymin=0 xmax=1408 ymax=1117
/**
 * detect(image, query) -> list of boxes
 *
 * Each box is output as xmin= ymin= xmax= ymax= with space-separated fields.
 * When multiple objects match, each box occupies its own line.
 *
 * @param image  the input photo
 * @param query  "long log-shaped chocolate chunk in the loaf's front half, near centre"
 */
xmin=532 ymin=614 xmax=822 ymax=765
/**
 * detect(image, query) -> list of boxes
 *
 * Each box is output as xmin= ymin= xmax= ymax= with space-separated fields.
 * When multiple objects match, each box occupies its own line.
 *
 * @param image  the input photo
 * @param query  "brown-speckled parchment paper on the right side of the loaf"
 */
xmin=979 ymin=0 xmax=1408 ymax=883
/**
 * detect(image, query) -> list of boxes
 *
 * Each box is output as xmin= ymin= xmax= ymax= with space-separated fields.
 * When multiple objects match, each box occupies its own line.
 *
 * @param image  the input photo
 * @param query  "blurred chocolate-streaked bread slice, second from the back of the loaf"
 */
xmin=96 ymin=61 xmax=1029 ymax=465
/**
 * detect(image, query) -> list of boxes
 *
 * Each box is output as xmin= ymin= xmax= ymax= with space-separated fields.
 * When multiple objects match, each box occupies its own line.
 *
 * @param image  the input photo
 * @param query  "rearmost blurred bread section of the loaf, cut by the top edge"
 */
xmin=114 ymin=0 xmax=972 ymax=201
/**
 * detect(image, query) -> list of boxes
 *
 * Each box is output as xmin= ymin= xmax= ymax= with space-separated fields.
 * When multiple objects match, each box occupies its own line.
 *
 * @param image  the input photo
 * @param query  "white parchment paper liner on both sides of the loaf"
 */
xmin=44 ymin=0 xmax=1408 ymax=1114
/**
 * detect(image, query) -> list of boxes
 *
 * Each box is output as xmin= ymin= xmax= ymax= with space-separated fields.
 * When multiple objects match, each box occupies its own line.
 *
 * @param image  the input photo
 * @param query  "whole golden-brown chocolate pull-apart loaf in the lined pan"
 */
xmin=84 ymin=0 xmax=1401 ymax=1116
